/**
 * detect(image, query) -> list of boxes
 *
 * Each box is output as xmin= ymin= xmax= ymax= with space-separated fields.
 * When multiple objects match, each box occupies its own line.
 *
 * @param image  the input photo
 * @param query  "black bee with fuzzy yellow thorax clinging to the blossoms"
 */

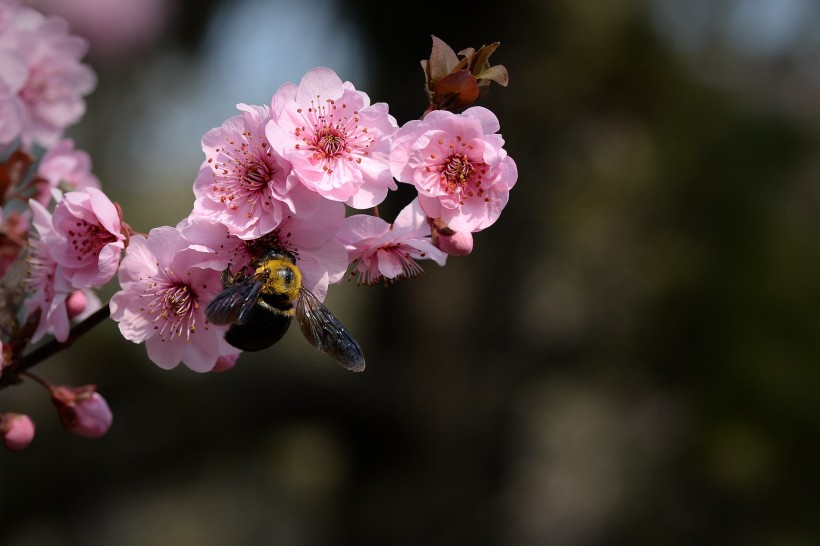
xmin=205 ymin=248 xmax=364 ymax=372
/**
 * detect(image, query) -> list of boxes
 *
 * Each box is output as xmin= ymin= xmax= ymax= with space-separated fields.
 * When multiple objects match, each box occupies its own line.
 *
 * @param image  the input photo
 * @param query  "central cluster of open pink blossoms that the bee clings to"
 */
xmin=111 ymin=68 xmax=517 ymax=372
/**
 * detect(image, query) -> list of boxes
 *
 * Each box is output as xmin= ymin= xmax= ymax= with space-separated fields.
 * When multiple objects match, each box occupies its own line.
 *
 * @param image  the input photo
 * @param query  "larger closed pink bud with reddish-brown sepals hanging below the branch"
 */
xmin=51 ymin=385 xmax=113 ymax=438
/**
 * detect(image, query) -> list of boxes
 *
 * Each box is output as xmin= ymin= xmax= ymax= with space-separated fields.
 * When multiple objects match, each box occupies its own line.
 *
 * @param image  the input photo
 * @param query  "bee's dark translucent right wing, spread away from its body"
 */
xmin=296 ymin=287 xmax=364 ymax=372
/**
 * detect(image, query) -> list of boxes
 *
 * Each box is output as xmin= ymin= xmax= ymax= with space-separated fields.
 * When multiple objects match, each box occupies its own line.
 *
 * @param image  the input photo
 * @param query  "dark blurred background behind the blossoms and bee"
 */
xmin=0 ymin=0 xmax=820 ymax=546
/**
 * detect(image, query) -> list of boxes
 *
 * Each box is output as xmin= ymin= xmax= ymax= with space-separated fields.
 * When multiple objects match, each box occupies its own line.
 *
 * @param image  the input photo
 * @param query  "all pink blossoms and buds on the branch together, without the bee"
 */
xmin=0 ymin=0 xmax=517 ymax=449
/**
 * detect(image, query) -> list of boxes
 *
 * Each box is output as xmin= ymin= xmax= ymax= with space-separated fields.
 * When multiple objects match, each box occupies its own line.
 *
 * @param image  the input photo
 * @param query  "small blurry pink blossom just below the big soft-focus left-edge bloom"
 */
xmin=36 ymin=138 xmax=100 ymax=205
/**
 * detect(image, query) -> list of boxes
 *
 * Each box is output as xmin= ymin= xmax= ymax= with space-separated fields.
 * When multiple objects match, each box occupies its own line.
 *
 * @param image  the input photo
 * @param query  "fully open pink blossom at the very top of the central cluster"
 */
xmin=265 ymin=68 xmax=398 ymax=209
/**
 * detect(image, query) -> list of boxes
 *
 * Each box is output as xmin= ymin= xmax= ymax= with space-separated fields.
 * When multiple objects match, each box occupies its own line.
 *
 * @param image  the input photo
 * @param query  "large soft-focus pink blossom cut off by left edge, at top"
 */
xmin=0 ymin=3 xmax=96 ymax=148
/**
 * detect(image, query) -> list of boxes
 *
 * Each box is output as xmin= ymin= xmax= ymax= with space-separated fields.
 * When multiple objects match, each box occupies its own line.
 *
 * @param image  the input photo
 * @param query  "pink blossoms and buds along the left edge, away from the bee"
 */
xmin=0 ymin=0 xmax=119 ymax=450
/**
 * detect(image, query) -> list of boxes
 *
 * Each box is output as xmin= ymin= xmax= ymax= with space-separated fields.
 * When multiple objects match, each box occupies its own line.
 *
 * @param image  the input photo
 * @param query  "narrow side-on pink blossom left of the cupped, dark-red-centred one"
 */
xmin=25 ymin=200 xmax=72 ymax=342
